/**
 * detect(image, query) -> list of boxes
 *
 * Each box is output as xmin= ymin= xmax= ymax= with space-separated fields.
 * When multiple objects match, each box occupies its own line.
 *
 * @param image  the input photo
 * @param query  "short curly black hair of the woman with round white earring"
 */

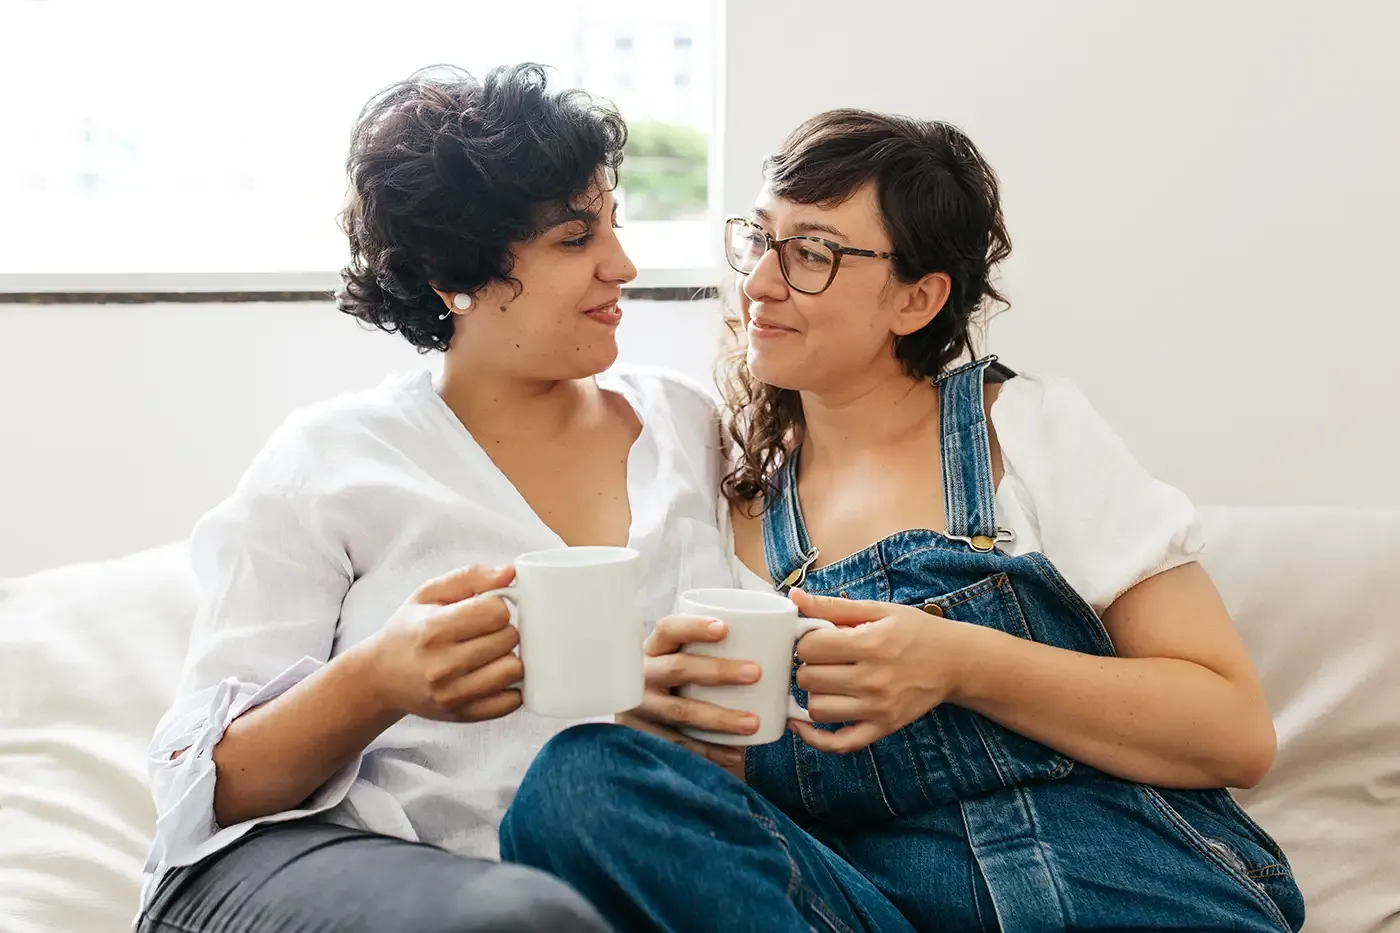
xmin=336 ymin=63 xmax=627 ymax=352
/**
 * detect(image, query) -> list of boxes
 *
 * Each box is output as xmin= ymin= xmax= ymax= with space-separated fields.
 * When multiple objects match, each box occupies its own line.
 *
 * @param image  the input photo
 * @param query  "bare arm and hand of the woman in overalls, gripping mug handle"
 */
xmin=794 ymin=563 xmax=1275 ymax=787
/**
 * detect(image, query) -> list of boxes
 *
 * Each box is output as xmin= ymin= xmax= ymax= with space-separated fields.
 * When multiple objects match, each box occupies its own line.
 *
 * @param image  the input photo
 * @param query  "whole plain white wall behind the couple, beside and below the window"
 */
xmin=0 ymin=0 xmax=1400 ymax=574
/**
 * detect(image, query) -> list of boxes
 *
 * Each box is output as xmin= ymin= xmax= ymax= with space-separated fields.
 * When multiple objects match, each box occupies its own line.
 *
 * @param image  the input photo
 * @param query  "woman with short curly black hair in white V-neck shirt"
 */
xmin=139 ymin=64 xmax=732 ymax=933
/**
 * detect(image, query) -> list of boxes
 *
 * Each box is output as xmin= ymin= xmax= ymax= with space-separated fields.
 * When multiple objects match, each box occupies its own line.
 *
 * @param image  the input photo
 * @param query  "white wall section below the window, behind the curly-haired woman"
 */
xmin=0 ymin=301 xmax=720 ymax=577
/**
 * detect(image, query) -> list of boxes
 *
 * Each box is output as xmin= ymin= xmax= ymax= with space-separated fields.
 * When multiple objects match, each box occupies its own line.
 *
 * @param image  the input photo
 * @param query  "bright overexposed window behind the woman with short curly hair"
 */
xmin=0 ymin=0 xmax=718 ymax=289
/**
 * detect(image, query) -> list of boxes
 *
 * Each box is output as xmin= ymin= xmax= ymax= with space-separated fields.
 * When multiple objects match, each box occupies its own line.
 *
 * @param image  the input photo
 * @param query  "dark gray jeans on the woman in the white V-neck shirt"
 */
xmin=137 ymin=822 xmax=610 ymax=933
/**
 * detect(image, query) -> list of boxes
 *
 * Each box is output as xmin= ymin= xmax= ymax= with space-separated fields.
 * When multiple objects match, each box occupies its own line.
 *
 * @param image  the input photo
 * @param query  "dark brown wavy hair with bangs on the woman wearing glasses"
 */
xmin=721 ymin=109 xmax=1011 ymax=503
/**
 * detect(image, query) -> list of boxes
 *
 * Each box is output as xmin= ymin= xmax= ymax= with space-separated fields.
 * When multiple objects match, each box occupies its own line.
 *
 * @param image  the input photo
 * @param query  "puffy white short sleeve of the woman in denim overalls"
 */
xmin=991 ymin=375 xmax=1204 ymax=614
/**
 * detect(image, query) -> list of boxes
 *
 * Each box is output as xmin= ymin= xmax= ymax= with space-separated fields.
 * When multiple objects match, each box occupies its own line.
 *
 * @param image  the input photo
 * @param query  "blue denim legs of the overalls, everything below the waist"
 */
xmin=501 ymin=724 xmax=1302 ymax=933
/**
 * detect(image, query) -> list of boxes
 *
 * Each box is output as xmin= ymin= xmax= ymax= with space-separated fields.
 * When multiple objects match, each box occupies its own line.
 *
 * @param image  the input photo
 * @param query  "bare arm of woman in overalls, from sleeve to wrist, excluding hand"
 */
xmin=952 ymin=563 xmax=1275 ymax=787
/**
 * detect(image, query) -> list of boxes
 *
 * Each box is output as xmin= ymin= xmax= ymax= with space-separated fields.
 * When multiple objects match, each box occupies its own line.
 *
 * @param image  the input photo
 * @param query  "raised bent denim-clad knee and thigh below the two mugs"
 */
xmin=501 ymin=726 xmax=910 ymax=933
